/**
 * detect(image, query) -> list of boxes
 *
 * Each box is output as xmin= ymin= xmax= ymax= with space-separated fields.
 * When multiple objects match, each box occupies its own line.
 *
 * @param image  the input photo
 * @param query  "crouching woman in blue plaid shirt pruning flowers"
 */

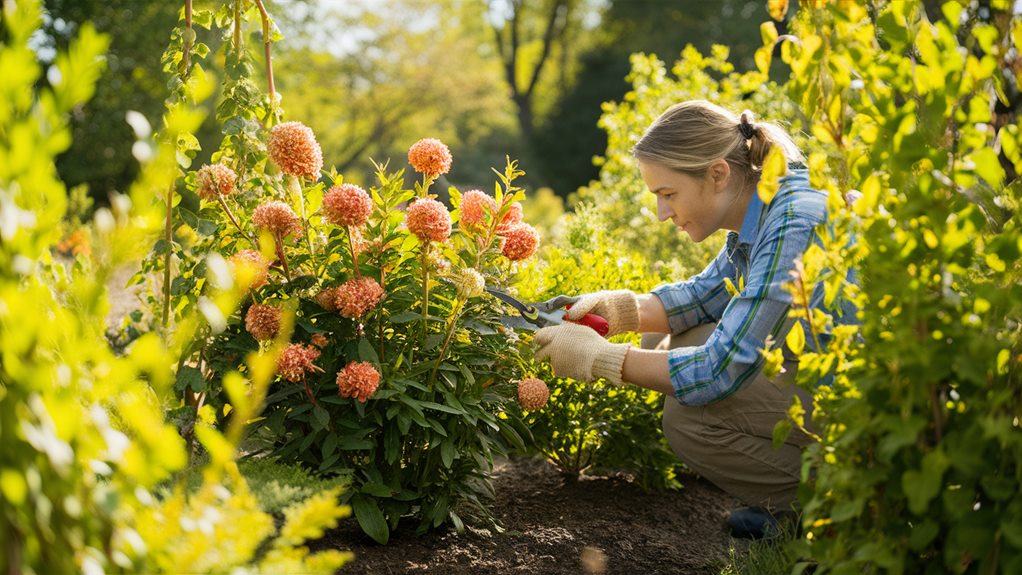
xmin=536 ymin=101 xmax=846 ymax=537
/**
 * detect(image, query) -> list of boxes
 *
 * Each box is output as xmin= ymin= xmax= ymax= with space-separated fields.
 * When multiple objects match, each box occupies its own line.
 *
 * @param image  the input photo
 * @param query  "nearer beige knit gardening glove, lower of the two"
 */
xmin=532 ymin=324 xmax=632 ymax=385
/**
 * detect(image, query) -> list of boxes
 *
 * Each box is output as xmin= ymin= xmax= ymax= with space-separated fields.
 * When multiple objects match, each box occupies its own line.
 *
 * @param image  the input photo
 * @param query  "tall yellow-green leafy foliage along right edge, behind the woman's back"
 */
xmin=757 ymin=1 xmax=1022 ymax=573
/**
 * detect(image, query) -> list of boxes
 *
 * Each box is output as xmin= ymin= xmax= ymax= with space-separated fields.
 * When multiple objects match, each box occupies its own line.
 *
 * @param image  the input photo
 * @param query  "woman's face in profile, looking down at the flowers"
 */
xmin=639 ymin=160 xmax=741 ymax=242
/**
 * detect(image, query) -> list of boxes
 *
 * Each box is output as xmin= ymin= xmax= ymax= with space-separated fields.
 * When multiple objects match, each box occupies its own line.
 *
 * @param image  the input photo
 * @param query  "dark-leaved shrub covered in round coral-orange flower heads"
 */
xmin=179 ymin=132 xmax=545 ymax=541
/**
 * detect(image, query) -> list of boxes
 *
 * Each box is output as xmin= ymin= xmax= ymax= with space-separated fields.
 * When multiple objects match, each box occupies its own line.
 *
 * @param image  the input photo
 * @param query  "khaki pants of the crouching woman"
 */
xmin=642 ymin=324 xmax=812 ymax=510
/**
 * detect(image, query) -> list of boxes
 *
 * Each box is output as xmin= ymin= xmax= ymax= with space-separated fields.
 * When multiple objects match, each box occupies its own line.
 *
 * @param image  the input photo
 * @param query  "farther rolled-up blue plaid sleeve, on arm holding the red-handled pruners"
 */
xmin=652 ymin=245 xmax=735 ymax=334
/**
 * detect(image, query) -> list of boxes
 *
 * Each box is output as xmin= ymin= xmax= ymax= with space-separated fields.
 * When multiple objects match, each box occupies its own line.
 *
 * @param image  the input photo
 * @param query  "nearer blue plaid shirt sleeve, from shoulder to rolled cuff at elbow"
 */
xmin=667 ymin=190 xmax=825 ymax=405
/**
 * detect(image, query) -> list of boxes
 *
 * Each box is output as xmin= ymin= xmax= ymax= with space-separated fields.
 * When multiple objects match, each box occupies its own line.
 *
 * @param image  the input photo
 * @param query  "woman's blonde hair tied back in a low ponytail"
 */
xmin=632 ymin=100 xmax=805 ymax=182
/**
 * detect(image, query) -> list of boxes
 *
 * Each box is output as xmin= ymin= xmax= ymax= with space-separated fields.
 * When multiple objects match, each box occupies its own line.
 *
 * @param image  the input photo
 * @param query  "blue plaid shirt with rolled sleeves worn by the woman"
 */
xmin=653 ymin=169 xmax=827 ymax=405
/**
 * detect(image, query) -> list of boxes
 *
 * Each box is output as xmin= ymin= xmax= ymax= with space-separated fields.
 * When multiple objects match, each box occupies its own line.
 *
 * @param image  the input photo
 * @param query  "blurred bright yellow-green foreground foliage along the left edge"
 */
xmin=0 ymin=1 xmax=349 ymax=574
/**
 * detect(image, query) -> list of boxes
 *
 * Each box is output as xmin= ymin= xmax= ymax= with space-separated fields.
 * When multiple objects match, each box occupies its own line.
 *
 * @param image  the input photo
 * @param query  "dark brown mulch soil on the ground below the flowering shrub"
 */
xmin=315 ymin=458 xmax=738 ymax=575
